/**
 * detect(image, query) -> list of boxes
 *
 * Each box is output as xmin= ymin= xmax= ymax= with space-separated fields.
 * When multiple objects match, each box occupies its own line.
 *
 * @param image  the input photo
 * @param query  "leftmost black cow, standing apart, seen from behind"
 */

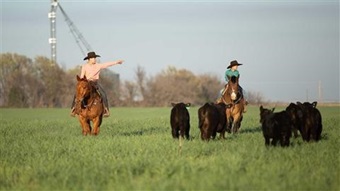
xmin=170 ymin=102 xmax=191 ymax=139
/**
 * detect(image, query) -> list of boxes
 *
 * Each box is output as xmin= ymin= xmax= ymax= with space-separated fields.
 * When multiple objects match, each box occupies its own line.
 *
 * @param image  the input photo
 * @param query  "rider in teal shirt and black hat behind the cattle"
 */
xmin=217 ymin=60 xmax=247 ymax=112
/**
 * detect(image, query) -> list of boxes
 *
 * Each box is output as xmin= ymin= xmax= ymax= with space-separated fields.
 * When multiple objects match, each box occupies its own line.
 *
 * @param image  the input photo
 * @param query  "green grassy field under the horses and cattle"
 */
xmin=0 ymin=106 xmax=340 ymax=191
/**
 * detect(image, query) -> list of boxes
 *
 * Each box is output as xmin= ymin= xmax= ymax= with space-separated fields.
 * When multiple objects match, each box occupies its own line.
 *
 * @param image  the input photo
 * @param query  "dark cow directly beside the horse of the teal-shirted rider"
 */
xmin=198 ymin=103 xmax=226 ymax=141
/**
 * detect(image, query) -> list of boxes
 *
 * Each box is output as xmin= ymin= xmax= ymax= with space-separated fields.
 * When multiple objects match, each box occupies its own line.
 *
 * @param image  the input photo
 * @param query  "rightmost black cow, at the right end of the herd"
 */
xmin=286 ymin=102 xmax=322 ymax=142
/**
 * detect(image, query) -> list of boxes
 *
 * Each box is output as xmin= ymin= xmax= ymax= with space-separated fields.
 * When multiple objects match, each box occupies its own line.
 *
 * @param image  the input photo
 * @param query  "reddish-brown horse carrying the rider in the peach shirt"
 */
xmin=75 ymin=75 xmax=104 ymax=135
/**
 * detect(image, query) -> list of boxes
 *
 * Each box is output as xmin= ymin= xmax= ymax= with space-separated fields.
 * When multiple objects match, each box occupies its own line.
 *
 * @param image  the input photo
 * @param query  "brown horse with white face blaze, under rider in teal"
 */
xmin=220 ymin=76 xmax=244 ymax=133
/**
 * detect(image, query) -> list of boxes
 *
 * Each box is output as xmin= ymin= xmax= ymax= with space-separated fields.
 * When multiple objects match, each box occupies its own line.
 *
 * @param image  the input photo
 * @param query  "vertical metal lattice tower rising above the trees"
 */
xmin=48 ymin=0 xmax=58 ymax=65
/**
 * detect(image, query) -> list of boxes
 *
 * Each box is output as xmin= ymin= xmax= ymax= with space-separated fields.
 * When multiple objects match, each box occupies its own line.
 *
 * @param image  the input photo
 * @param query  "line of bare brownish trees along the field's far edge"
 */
xmin=0 ymin=53 xmax=262 ymax=108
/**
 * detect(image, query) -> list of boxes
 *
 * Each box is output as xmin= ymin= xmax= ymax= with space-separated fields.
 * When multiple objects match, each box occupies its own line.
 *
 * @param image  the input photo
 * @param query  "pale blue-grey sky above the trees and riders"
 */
xmin=0 ymin=0 xmax=340 ymax=102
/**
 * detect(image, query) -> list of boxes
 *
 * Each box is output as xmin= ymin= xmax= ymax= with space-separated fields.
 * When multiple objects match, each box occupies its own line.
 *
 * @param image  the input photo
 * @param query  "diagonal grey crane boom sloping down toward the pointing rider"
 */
xmin=59 ymin=4 xmax=92 ymax=55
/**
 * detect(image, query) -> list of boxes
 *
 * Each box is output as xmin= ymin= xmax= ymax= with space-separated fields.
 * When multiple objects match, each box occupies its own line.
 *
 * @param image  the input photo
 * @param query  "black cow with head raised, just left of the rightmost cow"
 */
xmin=260 ymin=105 xmax=292 ymax=147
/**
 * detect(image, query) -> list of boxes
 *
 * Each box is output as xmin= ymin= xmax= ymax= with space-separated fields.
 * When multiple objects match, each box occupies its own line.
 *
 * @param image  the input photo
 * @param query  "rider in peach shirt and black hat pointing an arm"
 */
xmin=70 ymin=52 xmax=124 ymax=117
